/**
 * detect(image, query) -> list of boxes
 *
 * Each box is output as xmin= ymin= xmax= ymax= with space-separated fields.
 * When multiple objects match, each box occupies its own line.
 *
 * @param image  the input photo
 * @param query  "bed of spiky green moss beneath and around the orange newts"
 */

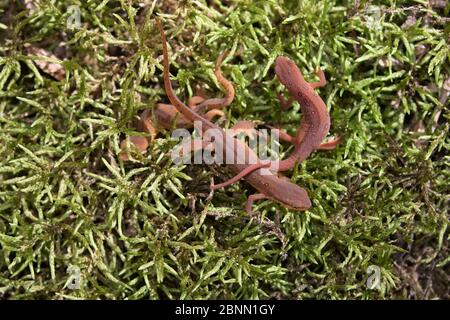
xmin=0 ymin=0 xmax=450 ymax=299
